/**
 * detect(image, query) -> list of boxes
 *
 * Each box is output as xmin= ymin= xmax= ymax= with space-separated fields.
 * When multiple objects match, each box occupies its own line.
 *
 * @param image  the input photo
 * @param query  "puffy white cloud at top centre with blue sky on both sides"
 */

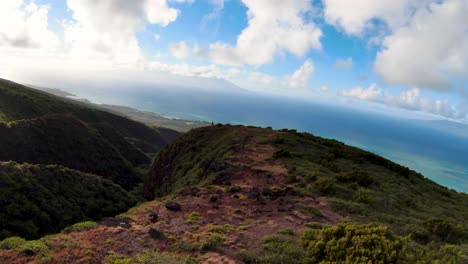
xmin=207 ymin=0 xmax=322 ymax=66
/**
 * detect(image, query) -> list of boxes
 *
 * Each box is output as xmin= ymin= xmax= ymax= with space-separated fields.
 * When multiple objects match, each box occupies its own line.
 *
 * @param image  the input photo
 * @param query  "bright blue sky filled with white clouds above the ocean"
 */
xmin=0 ymin=0 xmax=468 ymax=123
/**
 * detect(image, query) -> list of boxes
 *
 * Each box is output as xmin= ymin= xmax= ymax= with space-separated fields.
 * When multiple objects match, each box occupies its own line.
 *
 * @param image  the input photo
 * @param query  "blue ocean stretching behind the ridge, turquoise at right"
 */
xmin=79 ymin=87 xmax=468 ymax=192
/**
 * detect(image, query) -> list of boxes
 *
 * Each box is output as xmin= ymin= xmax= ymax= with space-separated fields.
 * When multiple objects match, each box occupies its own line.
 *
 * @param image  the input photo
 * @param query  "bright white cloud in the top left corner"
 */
xmin=0 ymin=0 xmax=59 ymax=50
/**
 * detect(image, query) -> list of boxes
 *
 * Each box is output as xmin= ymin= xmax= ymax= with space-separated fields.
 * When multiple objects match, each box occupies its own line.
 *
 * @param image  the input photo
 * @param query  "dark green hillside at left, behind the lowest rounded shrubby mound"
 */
xmin=0 ymin=80 xmax=180 ymax=189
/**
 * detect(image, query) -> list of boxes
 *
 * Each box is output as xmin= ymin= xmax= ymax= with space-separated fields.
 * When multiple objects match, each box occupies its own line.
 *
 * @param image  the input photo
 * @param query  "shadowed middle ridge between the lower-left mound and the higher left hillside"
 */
xmin=0 ymin=115 xmax=140 ymax=189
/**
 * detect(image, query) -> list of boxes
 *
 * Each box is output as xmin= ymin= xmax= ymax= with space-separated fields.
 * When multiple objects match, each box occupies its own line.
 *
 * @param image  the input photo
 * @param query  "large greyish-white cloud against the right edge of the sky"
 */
xmin=375 ymin=0 xmax=468 ymax=88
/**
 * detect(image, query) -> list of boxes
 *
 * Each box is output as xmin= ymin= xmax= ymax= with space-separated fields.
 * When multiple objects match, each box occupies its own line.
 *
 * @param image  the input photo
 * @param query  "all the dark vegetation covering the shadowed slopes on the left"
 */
xmin=0 ymin=79 xmax=179 ymax=241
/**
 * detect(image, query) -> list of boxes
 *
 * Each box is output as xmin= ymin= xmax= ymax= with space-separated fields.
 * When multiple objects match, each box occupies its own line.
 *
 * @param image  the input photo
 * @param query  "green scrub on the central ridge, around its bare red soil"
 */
xmin=145 ymin=125 xmax=468 ymax=263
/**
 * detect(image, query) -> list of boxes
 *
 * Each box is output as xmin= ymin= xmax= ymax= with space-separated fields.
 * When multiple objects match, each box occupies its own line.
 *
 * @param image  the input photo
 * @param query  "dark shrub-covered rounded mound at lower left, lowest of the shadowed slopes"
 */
xmin=0 ymin=162 xmax=135 ymax=239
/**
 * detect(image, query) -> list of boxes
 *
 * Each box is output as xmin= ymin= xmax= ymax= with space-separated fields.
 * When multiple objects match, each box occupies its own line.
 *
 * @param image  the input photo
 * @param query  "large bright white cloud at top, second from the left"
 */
xmin=64 ymin=0 xmax=183 ymax=65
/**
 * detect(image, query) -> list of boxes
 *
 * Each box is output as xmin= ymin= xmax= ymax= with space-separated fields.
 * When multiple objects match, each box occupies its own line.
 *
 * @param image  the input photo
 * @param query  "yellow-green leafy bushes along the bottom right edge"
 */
xmin=239 ymin=223 xmax=468 ymax=264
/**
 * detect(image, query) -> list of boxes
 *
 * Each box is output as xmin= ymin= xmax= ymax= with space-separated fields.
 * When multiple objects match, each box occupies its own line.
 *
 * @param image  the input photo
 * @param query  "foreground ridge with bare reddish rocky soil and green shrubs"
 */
xmin=0 ymin=125 xmax=468 ymax=263
